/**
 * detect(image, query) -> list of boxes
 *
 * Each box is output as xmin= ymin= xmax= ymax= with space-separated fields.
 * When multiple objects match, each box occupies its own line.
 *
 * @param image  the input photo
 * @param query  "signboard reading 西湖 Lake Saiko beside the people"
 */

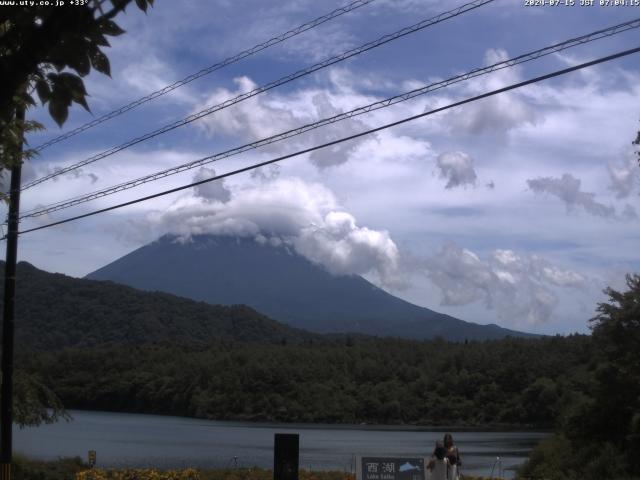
xmin=356 ymin=455 xmax=427 ymax=480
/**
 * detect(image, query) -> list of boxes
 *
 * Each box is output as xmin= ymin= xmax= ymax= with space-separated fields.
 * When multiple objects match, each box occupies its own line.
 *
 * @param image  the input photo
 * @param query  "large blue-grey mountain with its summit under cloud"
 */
xmin=86 ymin=235 xmax=528 ymax=341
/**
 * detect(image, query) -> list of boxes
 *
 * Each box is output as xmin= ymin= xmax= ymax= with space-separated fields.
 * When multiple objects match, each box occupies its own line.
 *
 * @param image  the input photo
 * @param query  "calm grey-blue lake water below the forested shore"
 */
xmin=14 ymin=411 xmax=548 ymax=478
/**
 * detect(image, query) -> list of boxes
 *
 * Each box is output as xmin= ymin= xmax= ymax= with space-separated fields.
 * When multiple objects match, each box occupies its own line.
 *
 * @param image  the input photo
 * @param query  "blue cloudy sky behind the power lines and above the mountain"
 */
xmin=5 ymin=0 xmax=640 ymax=334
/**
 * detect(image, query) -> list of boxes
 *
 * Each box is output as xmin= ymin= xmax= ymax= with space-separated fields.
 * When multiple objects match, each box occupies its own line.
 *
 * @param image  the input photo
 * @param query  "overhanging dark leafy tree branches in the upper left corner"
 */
xmin=0 ymin=0 xmax=153 ymax=173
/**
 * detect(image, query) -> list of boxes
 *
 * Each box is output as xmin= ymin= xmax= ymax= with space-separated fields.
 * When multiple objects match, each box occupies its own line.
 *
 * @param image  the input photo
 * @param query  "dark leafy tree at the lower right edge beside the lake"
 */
xmin=521 ymin=275 xmax=640 ymax=480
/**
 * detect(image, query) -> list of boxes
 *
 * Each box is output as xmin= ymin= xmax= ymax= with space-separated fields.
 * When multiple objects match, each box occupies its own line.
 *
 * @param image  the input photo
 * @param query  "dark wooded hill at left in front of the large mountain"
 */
xmin=0 ymin=262 xmax=319 ymax=350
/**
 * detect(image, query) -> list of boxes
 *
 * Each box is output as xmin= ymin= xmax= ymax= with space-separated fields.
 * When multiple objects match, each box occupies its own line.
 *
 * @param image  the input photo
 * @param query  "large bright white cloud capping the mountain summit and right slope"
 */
xmin=148 ymin=178 xmax=402 ymax=287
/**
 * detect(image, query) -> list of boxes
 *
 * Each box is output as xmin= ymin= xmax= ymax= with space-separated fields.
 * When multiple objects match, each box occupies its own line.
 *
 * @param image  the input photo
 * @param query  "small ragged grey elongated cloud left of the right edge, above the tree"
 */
xmin=527 ymin=173 xmax=615 ymax=218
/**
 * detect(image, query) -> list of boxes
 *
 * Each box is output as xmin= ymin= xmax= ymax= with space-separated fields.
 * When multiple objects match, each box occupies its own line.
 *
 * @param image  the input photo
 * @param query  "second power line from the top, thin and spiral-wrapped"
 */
xmin=22 ymin=0 xmax=494 ymax=190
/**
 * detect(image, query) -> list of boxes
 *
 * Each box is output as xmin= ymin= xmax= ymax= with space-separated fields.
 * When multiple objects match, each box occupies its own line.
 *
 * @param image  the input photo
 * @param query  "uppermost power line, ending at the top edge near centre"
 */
xmin=34 ymin=0 xmax=376 ymax=152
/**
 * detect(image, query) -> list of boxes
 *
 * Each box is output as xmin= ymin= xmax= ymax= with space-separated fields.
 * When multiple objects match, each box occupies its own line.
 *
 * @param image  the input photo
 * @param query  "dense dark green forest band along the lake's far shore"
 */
xmin=20 ymin=336 xmax=589 ymax=426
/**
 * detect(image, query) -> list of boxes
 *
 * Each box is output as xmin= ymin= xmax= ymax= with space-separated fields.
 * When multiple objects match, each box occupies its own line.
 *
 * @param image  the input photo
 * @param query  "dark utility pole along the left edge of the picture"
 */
xmin=0 ymin=105 xmax=25 ymax=480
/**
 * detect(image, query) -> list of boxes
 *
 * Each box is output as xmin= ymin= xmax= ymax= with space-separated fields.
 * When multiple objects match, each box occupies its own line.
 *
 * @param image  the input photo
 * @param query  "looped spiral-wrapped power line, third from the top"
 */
xmin=20 ymin=18 xmax=640 ymax=219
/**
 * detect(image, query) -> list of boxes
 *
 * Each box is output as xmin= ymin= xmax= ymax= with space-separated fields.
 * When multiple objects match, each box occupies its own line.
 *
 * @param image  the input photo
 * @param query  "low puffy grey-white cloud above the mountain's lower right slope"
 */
xmin=426 ymin=241 xmax=587 ymax=324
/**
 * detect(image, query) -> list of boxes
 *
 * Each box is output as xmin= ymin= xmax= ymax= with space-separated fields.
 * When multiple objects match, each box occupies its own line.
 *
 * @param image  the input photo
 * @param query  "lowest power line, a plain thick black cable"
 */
xmin=12 ymin=47 xmax=640 ymax=239
